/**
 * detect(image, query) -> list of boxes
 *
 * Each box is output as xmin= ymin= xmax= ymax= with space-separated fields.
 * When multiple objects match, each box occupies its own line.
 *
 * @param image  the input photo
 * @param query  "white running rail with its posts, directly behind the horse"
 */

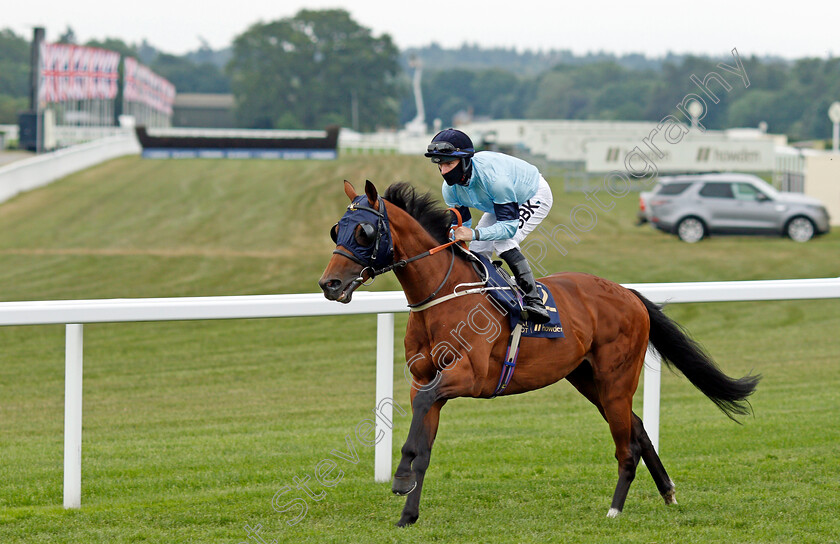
xmin=0 ymin=278 xmax=840 ymax=508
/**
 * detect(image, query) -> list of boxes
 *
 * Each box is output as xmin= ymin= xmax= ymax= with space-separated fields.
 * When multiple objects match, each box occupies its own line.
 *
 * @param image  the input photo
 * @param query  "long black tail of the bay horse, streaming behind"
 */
xmin=631 ymin=289 xmax=761 ymax=422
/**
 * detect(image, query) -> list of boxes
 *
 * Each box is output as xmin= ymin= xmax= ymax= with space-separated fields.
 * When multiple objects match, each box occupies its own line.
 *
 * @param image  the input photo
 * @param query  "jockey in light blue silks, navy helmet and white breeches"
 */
xmin=426 ymin=128 xmax=553 ymax=323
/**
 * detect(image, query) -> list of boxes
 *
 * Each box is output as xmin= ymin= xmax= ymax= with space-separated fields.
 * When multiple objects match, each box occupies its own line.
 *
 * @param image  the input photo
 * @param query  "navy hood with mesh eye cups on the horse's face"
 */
xmin=330 ymin=195 xmax=394 ymax=269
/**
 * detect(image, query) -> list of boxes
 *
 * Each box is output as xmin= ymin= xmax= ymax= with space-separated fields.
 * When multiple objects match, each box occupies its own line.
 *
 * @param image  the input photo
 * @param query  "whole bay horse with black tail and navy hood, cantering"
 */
xmin=319 ymin=181 xmax=760 ymax=527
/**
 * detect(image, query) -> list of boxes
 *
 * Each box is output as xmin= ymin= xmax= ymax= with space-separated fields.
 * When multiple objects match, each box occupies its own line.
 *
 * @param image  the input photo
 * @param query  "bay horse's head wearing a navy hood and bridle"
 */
xmin=318 ymin=181 xmax=394 ymax=304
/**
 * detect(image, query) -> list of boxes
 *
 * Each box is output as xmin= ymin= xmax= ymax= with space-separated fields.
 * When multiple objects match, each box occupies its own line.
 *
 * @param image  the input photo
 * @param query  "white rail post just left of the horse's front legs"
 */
xmin=373 ymin=314 xmax=394 ymax=482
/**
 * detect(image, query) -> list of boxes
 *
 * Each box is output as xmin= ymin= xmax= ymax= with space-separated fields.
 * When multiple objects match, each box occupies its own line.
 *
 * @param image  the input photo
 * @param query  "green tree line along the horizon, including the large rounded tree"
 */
xmin=0 ymin=9 xmax=840 ymax=140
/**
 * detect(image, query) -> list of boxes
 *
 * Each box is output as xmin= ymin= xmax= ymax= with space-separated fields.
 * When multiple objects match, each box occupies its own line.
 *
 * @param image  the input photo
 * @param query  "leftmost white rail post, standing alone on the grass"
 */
xmin=64 ymin=325 xmax=84 ymax=508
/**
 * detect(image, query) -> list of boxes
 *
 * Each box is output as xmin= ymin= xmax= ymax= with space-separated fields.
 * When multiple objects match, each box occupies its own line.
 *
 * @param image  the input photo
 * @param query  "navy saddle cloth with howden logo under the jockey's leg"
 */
xmin=473 ymin=253 xmax=565 ymax=338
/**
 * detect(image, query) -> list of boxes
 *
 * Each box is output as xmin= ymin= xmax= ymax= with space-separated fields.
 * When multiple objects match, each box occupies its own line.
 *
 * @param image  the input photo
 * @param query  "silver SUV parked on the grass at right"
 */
xmin=639 ymin=173 xmax=830 ymax=243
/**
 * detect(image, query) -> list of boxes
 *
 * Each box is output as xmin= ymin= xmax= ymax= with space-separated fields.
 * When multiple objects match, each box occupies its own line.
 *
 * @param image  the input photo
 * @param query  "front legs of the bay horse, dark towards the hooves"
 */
xmin=392 ymin=382 xmax=446 ymax=527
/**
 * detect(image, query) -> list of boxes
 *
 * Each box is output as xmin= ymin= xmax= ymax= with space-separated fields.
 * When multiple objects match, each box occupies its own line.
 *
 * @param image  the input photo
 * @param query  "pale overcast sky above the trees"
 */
xmin=0 ymin=0 xmax=840 ymax=58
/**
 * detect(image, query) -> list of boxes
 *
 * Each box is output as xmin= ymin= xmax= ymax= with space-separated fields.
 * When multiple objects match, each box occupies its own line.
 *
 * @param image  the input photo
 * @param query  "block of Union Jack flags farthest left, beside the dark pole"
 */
xmin=38 ymin=42 xmax=120 ymax=102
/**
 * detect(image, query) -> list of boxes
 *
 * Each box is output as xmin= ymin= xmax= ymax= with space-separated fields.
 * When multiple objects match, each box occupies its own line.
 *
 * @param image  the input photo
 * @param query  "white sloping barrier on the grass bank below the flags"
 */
xmin=0 ymin=134 xmax=140 ymax=202
